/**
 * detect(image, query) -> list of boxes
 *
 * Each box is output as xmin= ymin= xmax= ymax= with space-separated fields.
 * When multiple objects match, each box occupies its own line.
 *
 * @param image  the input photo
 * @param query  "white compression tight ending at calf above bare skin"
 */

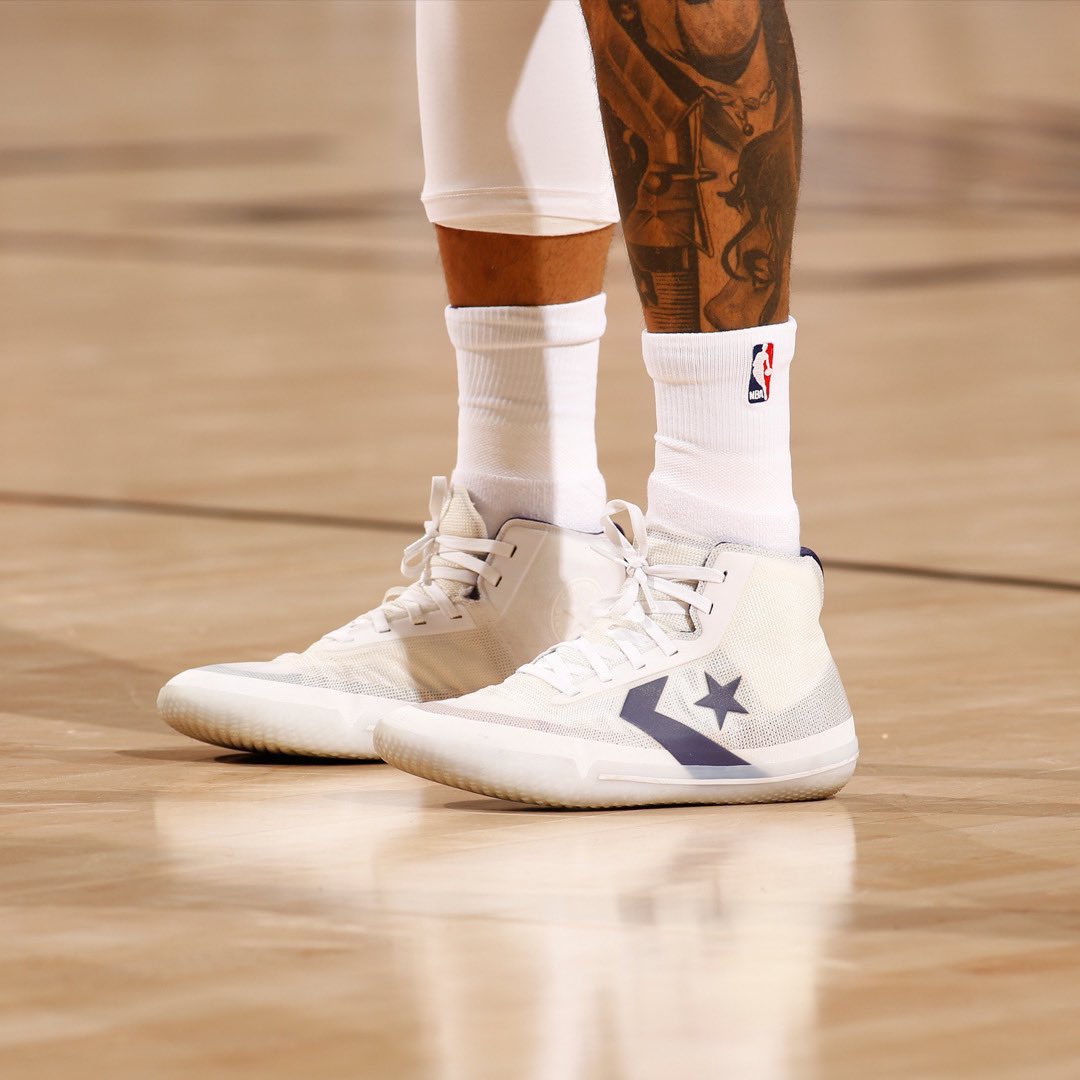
xmin=416 ymin=0 xmax=619 ymax=235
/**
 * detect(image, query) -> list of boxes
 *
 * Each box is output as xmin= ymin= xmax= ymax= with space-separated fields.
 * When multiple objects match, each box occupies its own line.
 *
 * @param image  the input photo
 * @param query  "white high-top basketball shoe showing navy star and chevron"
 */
xmin=375 ymin=501 xmax=859 ymax=807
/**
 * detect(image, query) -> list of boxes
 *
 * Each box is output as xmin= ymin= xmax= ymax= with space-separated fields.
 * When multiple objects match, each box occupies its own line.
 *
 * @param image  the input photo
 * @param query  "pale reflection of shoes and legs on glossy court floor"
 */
xmin=156 ymin=784 xmax=855 ymax=1080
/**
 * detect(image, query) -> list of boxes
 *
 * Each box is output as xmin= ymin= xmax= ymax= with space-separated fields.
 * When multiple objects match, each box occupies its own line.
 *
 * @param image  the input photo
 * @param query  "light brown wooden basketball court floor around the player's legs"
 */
xmin=0 ymin=0 xmax=1080 ymax=1080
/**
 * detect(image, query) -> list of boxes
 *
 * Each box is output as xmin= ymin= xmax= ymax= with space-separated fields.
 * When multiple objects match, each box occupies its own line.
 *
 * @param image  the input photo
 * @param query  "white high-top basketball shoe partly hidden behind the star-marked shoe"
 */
xmin=158 ymin=476 xmax=621 ymax=760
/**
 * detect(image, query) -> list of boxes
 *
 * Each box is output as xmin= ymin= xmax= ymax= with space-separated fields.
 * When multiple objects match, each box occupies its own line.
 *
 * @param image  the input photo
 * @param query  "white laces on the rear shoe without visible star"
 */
xmin=326 ymin=476 xmax=514 ymax=642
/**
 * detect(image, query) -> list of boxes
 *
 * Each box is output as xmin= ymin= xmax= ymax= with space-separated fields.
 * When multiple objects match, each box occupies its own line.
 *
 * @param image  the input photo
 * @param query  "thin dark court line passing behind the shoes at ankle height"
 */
xmin=0 ymin=490 xmax=1080 ymax=593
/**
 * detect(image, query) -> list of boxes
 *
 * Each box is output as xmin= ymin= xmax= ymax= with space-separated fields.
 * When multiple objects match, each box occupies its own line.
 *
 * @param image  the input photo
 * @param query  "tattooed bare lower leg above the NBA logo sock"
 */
xmin=581 ymin=0 xmax=801 ymax=333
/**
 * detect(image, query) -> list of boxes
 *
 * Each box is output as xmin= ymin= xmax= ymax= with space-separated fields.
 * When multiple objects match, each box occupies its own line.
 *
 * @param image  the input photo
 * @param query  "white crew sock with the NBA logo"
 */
xmin=643 ymin=319 xmax=799 ymax=554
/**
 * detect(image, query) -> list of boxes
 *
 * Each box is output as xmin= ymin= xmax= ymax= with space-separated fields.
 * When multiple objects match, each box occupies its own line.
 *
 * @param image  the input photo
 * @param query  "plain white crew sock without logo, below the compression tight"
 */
xmin=446 ymin=293 xmax=607 ymax=536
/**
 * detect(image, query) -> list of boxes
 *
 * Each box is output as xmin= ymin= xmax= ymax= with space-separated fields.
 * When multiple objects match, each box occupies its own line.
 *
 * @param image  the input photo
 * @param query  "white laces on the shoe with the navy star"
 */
xmin=518 ymin=499 xmax=727 ymax=694
